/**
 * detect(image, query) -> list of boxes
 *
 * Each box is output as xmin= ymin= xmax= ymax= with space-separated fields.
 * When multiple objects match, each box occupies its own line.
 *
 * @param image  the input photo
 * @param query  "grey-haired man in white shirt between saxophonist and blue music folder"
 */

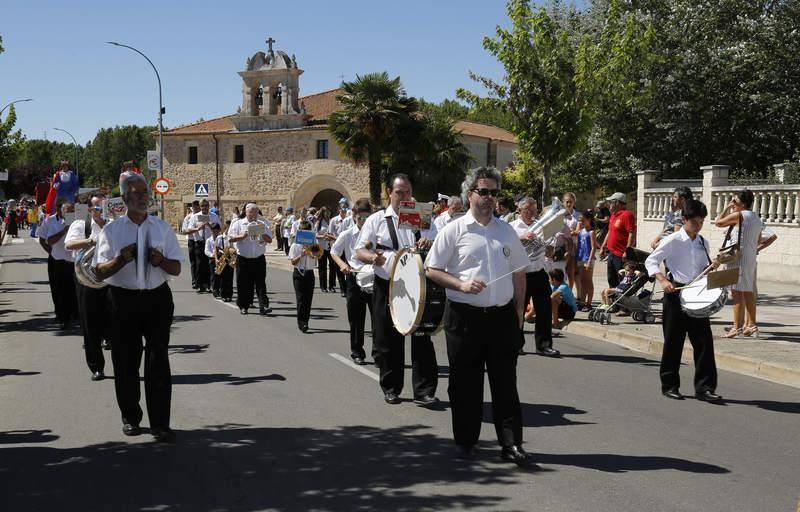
xmin=228 ymin=203 xmax=272 ymax=315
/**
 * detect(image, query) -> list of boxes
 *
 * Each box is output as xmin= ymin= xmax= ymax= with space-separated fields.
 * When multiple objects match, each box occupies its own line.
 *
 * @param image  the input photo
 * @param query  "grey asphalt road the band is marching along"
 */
xmin=0 ymin=234 xmax=800 ymax=512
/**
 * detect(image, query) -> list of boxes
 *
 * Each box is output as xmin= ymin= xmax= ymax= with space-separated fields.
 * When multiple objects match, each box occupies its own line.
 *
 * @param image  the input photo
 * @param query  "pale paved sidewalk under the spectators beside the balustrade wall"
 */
xmin=564 ymin=272 xmax=800 ymax=388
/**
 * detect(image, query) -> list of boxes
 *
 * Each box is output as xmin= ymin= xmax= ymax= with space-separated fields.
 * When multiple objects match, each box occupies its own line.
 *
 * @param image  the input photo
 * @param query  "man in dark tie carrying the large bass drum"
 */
xmin=356 ymin=174 xmax=439 ymax=406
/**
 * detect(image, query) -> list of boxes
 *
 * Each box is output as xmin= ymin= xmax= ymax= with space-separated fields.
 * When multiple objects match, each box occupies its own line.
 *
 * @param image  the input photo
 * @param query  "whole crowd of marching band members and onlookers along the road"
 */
xmin=4 ymin=163 xmax=775 ymax=464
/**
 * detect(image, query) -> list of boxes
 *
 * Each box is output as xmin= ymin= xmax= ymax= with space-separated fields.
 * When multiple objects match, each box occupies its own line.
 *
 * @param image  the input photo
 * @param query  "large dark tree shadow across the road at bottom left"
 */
xmin=0 ymin=425 xmax=520 ymax=512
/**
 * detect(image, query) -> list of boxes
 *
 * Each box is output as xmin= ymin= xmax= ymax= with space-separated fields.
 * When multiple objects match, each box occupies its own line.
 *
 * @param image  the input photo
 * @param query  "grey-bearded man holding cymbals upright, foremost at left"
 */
xmin=96 ymin=172 xmax=183 ymax=442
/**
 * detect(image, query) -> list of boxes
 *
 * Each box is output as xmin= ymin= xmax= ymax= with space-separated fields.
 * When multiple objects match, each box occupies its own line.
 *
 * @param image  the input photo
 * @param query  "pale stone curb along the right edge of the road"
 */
xmin=562 ymin=321 xmax=800 ymax=388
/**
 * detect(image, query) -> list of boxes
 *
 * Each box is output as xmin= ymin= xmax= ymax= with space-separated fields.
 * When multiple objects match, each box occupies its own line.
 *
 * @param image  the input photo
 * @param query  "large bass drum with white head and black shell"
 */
xmin=389 ymin=249 xmax=446 ymax=336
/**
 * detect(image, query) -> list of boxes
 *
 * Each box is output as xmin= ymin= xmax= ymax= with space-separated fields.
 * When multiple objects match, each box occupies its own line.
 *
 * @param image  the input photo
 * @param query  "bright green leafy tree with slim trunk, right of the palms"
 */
xmin=457 ymin=0 xmax=591 ymax=204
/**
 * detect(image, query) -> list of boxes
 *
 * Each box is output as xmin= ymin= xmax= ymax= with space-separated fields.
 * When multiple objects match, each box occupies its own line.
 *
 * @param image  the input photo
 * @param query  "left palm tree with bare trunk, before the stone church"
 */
xmin=328 ymin=71 xmax=417 ymax=205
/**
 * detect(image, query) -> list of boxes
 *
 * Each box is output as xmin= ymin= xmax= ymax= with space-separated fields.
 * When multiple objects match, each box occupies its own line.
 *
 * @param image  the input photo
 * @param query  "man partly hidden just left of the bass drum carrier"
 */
xmin=331 ymin=199 xmax=372 ymax=364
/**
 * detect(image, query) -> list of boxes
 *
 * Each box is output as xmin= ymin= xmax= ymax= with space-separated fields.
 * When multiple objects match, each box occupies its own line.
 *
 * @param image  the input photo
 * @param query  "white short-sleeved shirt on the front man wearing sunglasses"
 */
xmin=425 ymin=212 xmax=529 ymax=307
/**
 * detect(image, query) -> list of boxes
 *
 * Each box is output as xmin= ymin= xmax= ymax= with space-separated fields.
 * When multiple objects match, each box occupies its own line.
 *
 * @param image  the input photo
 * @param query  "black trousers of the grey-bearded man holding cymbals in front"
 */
xmin=109 ymin=283 xmax=175 ymax=428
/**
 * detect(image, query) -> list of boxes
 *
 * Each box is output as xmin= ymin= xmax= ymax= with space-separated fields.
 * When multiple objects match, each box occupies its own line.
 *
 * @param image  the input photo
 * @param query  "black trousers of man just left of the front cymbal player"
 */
xmin=75 ymin=281 xmax=113 ymax=373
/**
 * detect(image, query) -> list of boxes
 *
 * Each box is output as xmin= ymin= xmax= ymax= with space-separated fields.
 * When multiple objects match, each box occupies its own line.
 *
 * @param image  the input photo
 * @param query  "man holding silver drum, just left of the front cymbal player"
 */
xmin=64 ymin=193 xmax=111 ymax=381
